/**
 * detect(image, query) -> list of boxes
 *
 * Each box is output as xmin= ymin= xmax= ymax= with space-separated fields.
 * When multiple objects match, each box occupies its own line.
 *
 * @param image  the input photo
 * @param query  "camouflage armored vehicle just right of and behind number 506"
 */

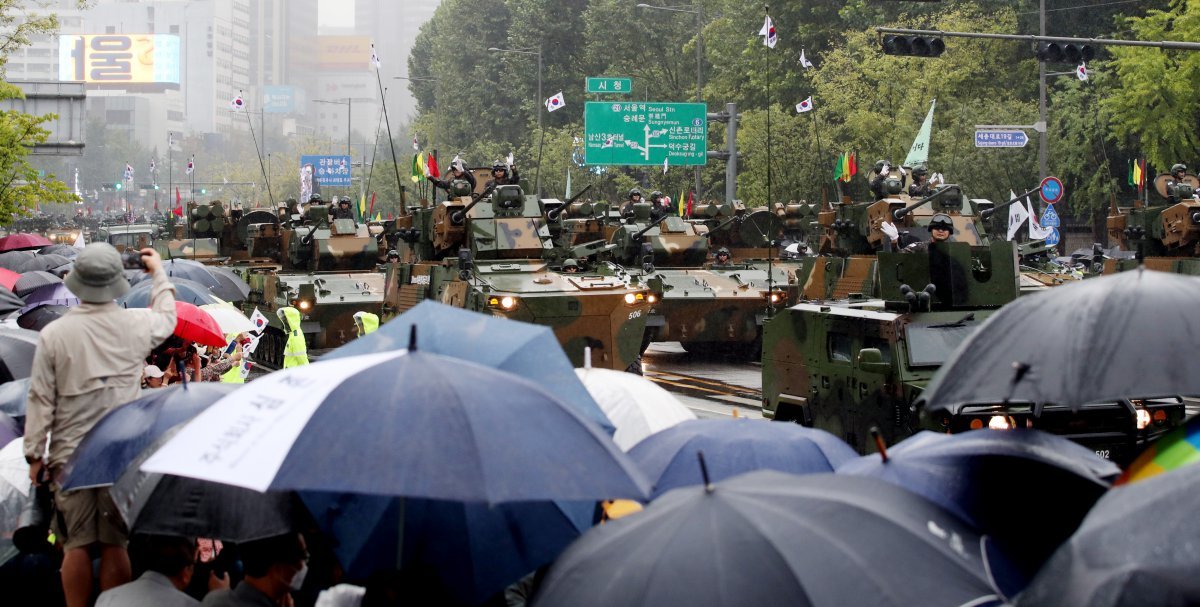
xmin=600 ymin=203 xmax=799 ymax=357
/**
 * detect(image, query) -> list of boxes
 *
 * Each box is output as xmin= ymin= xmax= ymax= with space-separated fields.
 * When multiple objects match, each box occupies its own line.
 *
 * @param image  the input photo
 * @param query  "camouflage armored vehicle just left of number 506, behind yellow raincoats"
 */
xmin=246 ymin=205 xmax=384 ymax=366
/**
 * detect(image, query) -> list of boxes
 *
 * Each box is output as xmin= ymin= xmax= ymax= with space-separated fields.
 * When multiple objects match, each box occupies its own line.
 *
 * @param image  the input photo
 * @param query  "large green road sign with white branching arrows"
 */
xmin=583 ymin=101 xmax=708 ymax=167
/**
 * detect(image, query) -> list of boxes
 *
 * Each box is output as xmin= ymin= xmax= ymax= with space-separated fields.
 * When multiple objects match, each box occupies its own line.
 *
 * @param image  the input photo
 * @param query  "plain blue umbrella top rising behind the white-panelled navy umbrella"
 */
xmin=322 ymin=301 xmax=616 ymax=434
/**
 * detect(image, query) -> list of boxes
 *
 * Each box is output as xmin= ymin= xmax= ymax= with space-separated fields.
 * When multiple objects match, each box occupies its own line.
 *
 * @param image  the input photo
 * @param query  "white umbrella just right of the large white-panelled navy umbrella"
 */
xmin=575 ymin=367 xmax=696 ymax=451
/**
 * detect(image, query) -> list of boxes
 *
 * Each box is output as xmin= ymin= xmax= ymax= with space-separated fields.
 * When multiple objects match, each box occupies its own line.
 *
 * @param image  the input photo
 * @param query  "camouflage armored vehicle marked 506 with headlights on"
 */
xmin=383 ymin=182 xmax=650 ymax=372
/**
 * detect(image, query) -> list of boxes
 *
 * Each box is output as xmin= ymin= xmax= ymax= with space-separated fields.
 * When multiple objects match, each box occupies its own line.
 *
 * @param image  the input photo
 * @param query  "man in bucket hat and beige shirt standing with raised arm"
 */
xmin=24 ymin=242 xmax=175 ymax=607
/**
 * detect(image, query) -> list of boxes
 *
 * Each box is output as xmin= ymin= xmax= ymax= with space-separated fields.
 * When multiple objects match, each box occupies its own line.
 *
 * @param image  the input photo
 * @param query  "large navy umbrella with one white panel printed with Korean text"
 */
xmin=144 ymin=349 xmax=647 ymax=504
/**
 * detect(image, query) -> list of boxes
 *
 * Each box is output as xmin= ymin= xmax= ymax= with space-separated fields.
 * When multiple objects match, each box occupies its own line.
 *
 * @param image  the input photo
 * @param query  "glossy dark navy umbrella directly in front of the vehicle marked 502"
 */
xmin=838 ymin=429 xmax=1121 ymax=578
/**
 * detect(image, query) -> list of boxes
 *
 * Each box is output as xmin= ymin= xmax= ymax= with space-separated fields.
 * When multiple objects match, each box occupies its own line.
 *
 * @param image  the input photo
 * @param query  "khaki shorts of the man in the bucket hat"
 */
xmin=52 ymin=483 xmax=130 ymax=549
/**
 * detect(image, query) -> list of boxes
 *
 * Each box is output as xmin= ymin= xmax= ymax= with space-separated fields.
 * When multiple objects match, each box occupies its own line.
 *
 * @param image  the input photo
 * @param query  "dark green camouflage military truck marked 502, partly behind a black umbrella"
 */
xmin=762 ymin=241 xmax=1183 ymax=458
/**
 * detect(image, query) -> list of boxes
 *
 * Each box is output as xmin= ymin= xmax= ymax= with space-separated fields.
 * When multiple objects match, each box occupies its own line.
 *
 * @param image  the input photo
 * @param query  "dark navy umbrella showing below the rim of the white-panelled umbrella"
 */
xmin=300 ymin=492 xmax=595 ymax=605
